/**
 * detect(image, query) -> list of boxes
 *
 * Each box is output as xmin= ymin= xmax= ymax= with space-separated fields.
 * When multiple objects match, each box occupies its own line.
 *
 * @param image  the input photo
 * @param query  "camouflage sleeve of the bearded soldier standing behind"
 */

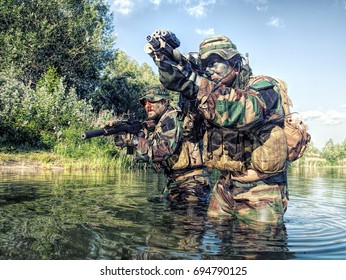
xmin=137 ymin=111 xmax=182 ymax=162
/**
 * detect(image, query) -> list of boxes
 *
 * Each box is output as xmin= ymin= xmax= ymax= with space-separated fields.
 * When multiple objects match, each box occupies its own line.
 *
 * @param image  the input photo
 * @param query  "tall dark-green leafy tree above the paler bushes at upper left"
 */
xmin=0 ymin=0 xmax=115 ymax=98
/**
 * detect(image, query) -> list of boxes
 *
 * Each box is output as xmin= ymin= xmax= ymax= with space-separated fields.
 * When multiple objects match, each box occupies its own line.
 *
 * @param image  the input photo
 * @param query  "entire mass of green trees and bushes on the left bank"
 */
xmin=0 ymin=0 xmax=158 ymax=156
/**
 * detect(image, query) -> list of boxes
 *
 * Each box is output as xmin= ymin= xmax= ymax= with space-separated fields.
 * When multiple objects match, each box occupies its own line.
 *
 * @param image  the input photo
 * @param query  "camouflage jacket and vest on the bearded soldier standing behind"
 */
xmin=136 ymin=108 xmax=203 ymax=178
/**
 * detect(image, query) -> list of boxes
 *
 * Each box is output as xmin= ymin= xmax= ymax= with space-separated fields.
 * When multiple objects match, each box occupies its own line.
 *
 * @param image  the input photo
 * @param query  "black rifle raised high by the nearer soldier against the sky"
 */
xmin=144 ymin=30 xmax=210 ymax=78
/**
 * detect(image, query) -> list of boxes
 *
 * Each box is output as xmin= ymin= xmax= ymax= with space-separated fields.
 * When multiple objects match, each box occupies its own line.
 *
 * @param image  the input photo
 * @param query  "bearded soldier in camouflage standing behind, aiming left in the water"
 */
xmin=115 ymin=85 xmax=211 ymax=203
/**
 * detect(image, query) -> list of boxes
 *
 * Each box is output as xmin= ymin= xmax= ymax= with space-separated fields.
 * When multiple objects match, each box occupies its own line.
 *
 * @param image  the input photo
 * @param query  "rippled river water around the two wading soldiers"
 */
xmin=0 ymin=166 xmax=346 ymax=260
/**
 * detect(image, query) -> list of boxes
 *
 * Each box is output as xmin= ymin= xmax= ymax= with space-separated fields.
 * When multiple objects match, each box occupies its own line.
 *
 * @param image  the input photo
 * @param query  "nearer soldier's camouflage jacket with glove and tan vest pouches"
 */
xmin=158 ymin=61 xmax=287 ymax=174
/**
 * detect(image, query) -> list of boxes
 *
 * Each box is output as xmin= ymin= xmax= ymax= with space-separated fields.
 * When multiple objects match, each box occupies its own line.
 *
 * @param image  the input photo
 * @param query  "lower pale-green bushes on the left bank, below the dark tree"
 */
xmin=0 ymin=68 xmax=92 ymax=148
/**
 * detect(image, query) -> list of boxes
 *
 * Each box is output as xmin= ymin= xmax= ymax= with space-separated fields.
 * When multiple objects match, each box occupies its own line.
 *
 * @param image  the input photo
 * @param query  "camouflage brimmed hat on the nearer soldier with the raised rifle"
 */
xmin=199 ymin=35 xmax=239 ymax=60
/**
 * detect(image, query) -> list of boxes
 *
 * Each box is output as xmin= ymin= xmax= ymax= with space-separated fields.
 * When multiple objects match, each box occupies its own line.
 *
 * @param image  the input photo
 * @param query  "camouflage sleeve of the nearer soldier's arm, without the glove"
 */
xmin=197 ymin=78 xmax=281 ymax=128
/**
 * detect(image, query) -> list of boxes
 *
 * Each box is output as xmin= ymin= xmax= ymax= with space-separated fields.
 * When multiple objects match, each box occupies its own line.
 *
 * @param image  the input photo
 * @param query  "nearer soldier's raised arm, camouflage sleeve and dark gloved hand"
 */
xmin=154 ymin=56 xmax=281 ymax=128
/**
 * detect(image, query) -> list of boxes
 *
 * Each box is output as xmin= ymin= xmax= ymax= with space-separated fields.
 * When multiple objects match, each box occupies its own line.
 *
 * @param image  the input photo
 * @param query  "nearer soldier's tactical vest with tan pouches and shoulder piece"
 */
xmin=203 ymin=76 xmax=289 ymax=174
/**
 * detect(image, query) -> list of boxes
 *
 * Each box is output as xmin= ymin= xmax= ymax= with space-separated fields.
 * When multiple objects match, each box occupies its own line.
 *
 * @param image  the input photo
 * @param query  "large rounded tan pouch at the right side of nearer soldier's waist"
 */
xmin=251 ymin=124 xmax=287 ymax=174
